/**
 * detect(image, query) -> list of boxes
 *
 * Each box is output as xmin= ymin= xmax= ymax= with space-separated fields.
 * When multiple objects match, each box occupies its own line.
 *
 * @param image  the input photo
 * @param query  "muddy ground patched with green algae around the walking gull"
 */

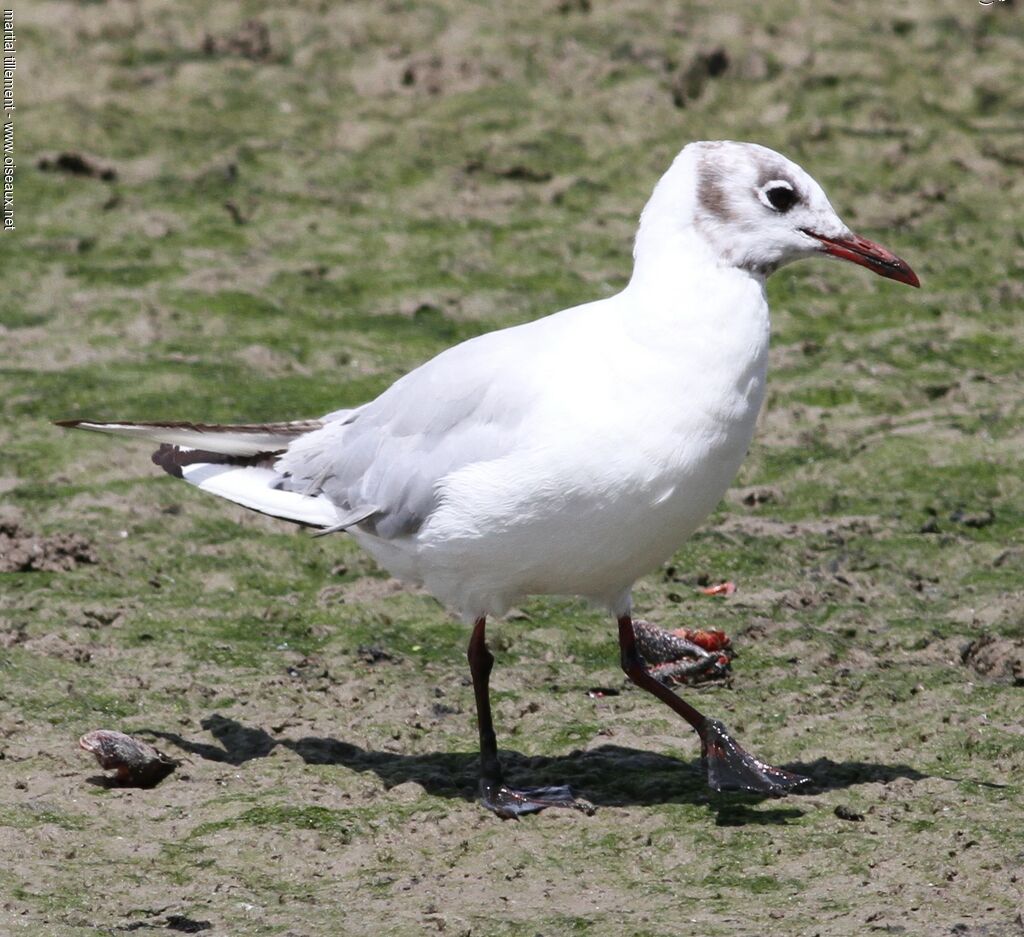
xmin=0 ymin=0 xmax=1024 ymax=937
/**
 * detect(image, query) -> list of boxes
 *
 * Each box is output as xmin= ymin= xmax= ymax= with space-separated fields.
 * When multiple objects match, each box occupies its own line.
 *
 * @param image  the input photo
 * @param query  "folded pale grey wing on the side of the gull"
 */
xmin=276 ymin=330 xmax=531 ymax=539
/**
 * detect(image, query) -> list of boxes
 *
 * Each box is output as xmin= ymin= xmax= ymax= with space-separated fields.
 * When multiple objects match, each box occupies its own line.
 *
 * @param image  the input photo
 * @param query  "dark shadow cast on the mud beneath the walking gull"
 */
xmin=147 ymin=714 xmax=942 ymax=825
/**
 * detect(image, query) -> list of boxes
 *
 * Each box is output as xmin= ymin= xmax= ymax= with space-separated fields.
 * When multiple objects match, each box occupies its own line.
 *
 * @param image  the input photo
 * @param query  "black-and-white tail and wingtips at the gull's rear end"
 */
xmin=57 ymin=415 xmax=368 ymax=533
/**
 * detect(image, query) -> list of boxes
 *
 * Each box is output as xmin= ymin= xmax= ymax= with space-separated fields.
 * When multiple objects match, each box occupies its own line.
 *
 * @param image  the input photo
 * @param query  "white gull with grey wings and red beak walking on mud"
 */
xmin=62 ymin=141 xmax=919 ymax=816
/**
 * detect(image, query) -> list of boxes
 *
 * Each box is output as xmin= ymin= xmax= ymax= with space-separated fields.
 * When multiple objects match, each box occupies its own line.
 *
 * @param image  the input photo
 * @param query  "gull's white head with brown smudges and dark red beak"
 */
xmin=636 ymin=140 xmax=920 ymax=287
